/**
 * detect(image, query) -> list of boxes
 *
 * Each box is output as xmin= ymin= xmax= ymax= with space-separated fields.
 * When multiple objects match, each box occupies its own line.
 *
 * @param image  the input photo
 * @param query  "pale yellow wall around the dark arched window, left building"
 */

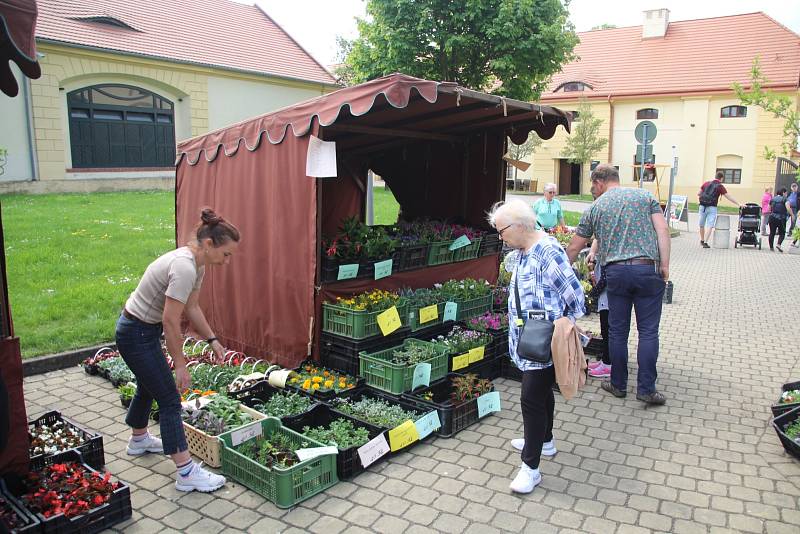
xmin=31 ymin=43 xmax=331 ymax=180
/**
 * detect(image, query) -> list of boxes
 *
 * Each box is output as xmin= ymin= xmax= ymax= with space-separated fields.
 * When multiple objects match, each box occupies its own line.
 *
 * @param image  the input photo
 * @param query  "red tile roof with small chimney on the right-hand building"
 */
xmin=542 ymin=13 xmax=800 ymax=102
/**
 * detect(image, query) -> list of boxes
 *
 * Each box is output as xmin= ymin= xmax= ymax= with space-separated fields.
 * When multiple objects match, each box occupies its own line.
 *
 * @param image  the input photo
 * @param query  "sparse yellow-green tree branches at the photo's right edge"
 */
xmin=733 ymin=56 xmax=800 ymax=182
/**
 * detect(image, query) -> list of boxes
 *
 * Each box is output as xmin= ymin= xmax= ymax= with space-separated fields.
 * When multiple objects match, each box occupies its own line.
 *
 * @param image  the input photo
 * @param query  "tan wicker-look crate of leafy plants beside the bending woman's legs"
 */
xmin=181 ymin=395 xmax=265 ymax=467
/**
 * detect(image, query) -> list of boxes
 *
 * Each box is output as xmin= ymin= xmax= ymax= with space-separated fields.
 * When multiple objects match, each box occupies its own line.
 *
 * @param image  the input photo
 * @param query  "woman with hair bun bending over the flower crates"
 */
xmin=116 ymin=208 xmax=240 ymax=491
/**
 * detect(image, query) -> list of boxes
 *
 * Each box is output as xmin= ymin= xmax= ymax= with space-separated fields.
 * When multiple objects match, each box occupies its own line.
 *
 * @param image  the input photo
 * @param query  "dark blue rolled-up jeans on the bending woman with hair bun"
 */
xmin=116 ymin=315 xmax=189 ymax=455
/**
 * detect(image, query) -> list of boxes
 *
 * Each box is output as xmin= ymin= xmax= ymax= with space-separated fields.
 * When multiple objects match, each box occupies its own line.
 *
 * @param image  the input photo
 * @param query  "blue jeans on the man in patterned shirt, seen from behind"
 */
xmin=606 ymin=264 xmax=665 ymax=395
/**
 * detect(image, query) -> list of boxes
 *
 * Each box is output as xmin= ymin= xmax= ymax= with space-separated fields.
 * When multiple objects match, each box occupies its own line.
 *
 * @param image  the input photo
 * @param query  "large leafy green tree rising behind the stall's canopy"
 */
xmin=339 ymin=0 xmax=578 ymax=101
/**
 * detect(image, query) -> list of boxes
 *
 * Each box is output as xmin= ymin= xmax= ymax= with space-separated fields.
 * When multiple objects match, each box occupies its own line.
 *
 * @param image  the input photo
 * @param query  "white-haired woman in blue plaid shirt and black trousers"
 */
xmin=488 ymin=199 xmax=584 ymax=493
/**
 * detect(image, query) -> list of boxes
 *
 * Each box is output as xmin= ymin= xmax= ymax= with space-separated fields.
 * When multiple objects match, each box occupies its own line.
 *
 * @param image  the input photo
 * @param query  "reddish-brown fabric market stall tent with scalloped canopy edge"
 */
xmin=176 ymin=74 xmax=570 ymax=366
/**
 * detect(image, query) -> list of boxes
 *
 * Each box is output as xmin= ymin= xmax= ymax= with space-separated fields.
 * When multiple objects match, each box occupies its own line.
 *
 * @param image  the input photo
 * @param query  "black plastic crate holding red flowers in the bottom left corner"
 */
xmin=15 ymin=450 xmax=133 ymax=534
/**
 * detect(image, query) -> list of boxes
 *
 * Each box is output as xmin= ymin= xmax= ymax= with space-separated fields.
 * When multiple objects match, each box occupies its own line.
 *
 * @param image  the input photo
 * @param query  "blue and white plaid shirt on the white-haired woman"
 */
xmin=506 ymin=236 xmax=585 ymax=371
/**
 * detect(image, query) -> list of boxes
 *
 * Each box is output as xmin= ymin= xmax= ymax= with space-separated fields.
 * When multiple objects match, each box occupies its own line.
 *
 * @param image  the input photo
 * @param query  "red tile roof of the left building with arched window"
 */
xmin=36 ymin=0 xmax=336 ymax=84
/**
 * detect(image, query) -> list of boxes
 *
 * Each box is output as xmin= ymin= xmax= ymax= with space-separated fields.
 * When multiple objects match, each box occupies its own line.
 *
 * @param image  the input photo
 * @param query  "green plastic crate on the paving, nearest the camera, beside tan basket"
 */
xmin=219 ymin=417 xmax=339 ymax=508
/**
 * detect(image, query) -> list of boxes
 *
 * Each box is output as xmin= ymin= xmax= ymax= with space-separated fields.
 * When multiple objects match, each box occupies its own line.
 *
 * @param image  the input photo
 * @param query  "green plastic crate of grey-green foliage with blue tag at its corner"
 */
xmin=359 ymin=339 xmax=449 ymax=395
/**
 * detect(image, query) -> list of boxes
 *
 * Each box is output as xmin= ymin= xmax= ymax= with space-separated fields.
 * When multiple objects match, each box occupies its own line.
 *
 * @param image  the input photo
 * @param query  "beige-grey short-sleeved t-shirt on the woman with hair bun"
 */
xmin=125 ymin=247 xmax=205 ymax=324
